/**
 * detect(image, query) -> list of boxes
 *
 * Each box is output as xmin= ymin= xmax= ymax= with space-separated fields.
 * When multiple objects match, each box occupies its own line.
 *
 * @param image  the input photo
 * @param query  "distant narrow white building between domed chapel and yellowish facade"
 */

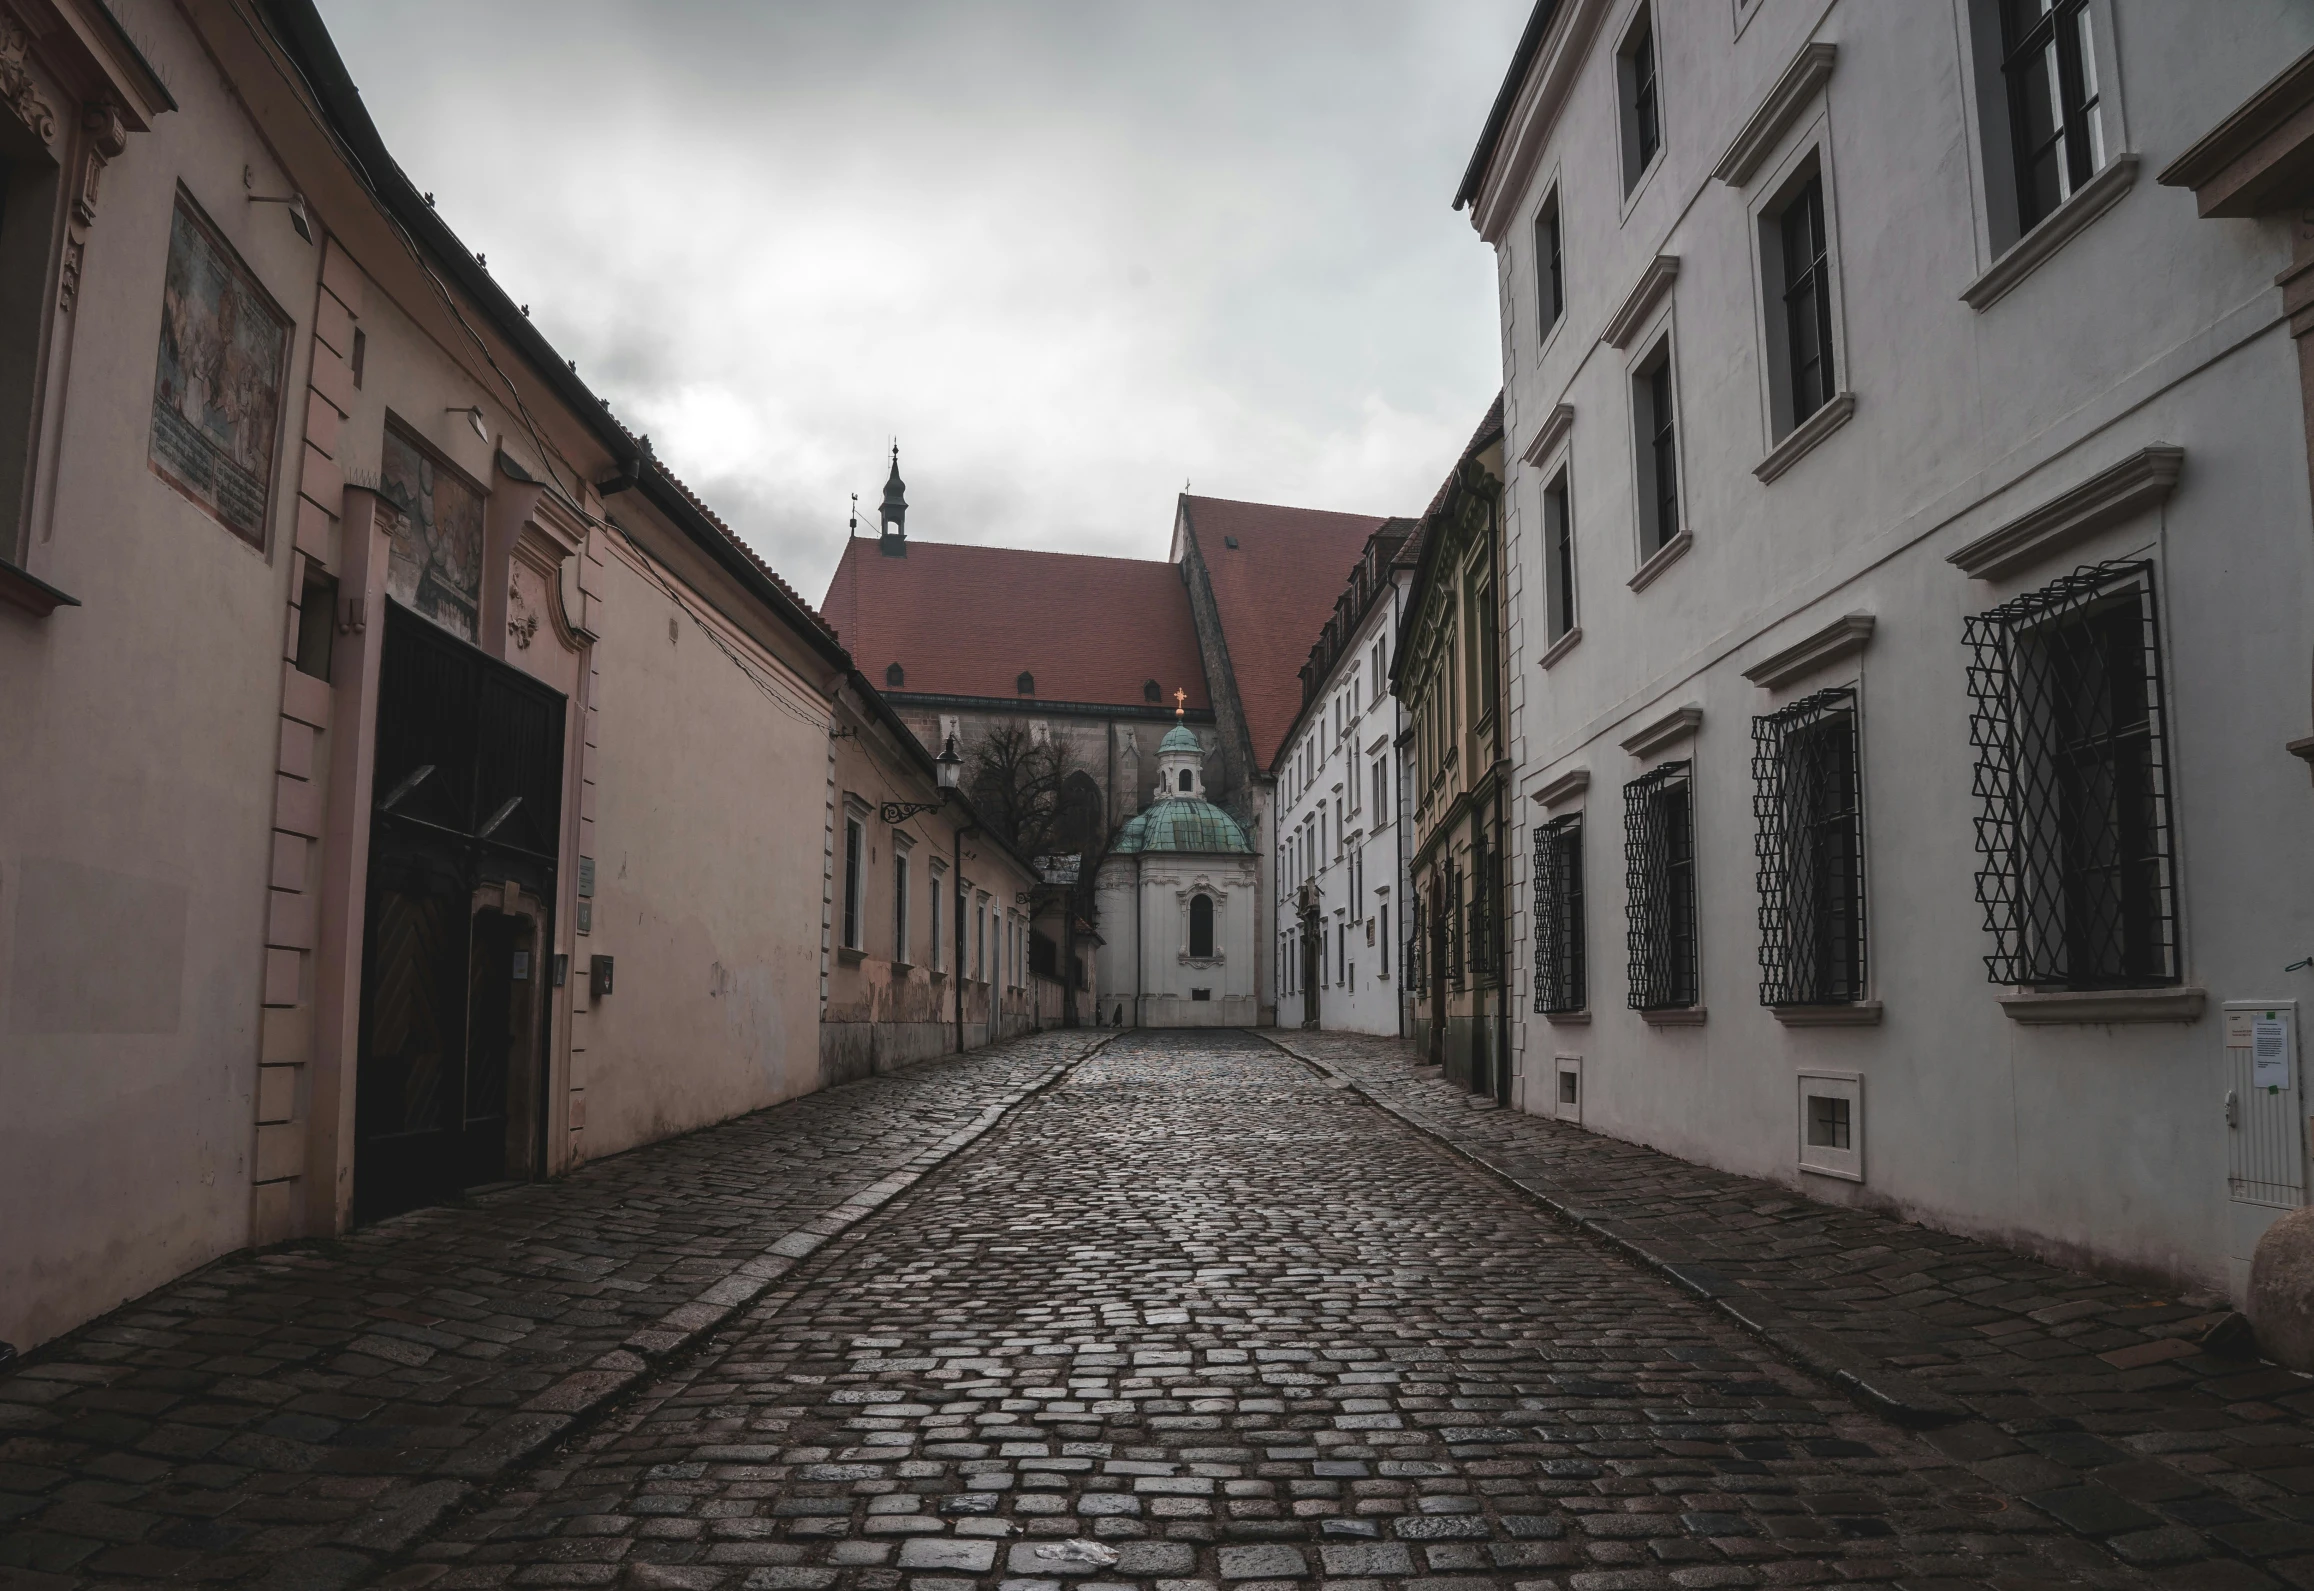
xmin=1270 ymin=520 xmax=1416 ymax=1036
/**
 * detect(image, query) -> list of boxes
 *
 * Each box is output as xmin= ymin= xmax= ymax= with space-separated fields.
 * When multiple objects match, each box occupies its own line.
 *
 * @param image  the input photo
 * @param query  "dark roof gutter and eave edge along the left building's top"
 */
xmin=261 ymin=0 xmax=852 ymax=668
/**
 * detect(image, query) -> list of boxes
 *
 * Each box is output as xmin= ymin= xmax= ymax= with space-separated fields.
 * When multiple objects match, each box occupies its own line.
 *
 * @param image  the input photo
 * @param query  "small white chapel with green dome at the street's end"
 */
xmin=1097 ymin=724 xmax=1261 ymax=1027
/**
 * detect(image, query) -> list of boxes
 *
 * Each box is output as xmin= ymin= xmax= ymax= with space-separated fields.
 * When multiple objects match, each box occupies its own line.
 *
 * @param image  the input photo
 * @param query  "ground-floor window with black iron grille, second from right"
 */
xmin=1752 ymin=685 xmax=1865 ymax=1006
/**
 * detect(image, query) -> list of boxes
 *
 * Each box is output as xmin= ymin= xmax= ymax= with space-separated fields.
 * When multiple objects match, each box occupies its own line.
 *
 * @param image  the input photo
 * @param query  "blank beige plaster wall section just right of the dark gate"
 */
xmin=572 ymin=545 xmax=828 ymax=1156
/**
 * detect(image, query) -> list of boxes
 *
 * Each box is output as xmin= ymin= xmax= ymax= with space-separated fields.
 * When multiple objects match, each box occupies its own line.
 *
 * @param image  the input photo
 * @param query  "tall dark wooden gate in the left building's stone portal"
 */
xmin=354 ymin=601 xmax=565 ymax=1221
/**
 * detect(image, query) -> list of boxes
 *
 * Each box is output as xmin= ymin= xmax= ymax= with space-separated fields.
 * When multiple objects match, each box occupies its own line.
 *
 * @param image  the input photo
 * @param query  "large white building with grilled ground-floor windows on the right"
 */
xmin=1460 ymin=0 xmax=2314 ymax=1295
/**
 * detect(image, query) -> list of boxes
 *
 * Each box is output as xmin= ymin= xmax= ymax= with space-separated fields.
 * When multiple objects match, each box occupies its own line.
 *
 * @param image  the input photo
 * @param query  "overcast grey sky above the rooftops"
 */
xmin=322 ymin=0 xmax=1527 ymax=601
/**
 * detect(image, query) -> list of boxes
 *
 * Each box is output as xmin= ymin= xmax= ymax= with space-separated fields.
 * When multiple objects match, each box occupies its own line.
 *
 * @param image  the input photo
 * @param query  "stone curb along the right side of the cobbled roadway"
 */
xmin=1261 ymin=1031 xmax=1978 ymax=1431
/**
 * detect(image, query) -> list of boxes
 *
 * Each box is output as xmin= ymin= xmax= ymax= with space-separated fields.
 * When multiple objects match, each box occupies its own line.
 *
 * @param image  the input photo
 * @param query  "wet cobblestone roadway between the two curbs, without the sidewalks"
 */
xmin=389 ymin=1034 xmax=2202 ymax=1591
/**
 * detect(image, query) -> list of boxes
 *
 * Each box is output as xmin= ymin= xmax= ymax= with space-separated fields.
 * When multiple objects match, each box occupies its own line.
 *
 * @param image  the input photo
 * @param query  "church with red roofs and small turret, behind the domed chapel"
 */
xmin=819 ymin=449 xmax=1386 ymax=1022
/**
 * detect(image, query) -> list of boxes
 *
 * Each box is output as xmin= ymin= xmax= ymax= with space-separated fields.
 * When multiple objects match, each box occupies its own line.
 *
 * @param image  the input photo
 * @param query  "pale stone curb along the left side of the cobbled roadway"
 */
xmin=330 ymin=1029 xmax=1125 ymax=1586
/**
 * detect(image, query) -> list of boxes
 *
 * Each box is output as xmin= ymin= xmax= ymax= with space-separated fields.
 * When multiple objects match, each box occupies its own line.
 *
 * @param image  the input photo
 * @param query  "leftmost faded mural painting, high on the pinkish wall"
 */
xmin=148 ymin=190 xmax=289 ymax=548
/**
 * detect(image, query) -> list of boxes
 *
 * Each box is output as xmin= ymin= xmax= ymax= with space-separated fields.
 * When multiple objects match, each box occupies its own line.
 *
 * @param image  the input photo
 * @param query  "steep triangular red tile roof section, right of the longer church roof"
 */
xmin=1180 ymin=497 xmax=1384 ymax=768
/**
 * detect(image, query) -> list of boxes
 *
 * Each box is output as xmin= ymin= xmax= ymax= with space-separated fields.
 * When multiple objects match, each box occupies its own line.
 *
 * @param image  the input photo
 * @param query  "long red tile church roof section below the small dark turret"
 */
xmin=819 ymin=537 xmax=1213 ymax=708
